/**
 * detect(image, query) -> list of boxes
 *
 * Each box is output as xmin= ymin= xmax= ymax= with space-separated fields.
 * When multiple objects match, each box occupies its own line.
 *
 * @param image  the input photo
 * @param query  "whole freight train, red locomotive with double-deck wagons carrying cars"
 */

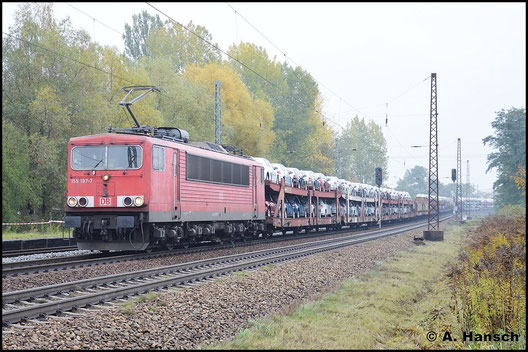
xmin=64 ymin=86 xmax=452 ymax=251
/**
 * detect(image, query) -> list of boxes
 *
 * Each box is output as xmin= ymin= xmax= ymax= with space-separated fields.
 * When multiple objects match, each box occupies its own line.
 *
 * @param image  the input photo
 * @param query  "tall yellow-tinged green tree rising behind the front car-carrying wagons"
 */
xmin=228 ymin=43 xmax=335 ymax=175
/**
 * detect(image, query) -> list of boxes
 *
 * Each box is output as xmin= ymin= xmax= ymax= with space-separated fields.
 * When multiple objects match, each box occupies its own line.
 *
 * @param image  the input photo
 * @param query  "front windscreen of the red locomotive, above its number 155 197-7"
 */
xmin=71 ymin=145 xmax=143 ymax=170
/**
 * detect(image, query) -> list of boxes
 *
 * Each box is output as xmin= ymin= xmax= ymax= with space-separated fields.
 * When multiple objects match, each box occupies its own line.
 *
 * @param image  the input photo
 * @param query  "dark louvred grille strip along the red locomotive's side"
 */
xmin=187 ymin=154 xmax=249 ymax=186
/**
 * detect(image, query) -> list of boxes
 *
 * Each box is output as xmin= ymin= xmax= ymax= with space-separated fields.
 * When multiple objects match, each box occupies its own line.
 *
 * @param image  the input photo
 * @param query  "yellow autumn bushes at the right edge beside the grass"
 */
xmin=450 ymin=212 xmax=526 ymax=340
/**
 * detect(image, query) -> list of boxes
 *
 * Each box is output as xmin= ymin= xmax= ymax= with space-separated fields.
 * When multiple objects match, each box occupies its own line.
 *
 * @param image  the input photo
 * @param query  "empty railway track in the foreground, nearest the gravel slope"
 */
xmin=2 ymin=216 xmax=451 ymax=326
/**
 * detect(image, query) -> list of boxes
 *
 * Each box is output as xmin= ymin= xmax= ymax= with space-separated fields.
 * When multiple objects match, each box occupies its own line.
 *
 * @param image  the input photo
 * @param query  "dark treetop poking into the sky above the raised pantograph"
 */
xmin=123 ymin=10 xmax=163 ymax=61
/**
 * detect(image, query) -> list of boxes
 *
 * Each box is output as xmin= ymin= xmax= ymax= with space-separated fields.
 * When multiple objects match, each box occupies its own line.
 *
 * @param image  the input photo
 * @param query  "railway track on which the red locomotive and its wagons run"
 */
xmin=2 ymin=217 xmax=424 ymax=277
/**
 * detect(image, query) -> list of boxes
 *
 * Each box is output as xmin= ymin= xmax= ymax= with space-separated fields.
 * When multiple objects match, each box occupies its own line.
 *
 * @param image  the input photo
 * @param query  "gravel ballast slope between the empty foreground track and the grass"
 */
xmin=2 ymin=221 xmax=452 ymax=349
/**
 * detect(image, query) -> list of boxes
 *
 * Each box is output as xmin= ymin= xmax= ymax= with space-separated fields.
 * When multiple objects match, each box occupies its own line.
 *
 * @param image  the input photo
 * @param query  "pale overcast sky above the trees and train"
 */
xmin=2 ymin=2 xmax=526 ymax=191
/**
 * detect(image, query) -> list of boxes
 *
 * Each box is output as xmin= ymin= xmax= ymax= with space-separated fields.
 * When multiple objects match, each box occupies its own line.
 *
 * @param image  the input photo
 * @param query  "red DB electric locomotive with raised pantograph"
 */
xmin=64 ymin=87 xmax=266 ymax=251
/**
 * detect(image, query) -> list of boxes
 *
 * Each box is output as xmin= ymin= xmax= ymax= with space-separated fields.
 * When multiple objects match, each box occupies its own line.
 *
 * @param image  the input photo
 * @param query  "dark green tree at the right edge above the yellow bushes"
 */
xmin=482 ymin=107 xmax=526 ymax=206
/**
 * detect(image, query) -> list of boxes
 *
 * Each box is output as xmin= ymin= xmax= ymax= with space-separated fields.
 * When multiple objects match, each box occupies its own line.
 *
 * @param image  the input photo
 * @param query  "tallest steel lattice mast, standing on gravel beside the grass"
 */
xmin=422 ymin=73 xmax=444 ymax=241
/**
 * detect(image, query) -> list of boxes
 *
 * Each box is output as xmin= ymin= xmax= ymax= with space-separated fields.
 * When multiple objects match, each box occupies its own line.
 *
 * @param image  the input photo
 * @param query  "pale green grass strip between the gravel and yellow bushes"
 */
xmin=209 ymin=225 xmax=478 ymax=349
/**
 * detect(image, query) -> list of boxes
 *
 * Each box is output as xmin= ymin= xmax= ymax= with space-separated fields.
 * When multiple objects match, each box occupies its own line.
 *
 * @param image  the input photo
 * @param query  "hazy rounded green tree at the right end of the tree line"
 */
xmin=335 ymin=116 xmax=389 ymax=185
